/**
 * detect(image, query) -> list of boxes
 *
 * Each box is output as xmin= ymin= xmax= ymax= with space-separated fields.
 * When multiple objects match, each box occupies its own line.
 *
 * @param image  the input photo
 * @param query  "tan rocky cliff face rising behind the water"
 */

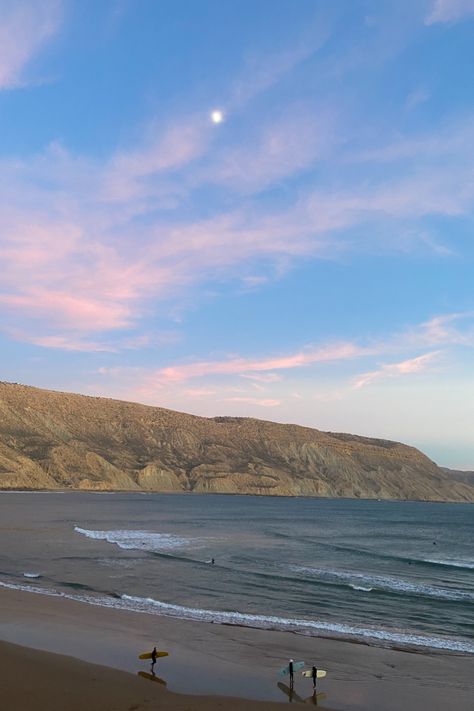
xmin=0 ymin=383 xmax=474 ymax=501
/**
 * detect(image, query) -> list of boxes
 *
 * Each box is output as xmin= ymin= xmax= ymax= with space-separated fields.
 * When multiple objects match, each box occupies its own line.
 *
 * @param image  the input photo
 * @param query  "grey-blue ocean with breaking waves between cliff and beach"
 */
xmin=0 ymin=492 xmax=474 ymax=654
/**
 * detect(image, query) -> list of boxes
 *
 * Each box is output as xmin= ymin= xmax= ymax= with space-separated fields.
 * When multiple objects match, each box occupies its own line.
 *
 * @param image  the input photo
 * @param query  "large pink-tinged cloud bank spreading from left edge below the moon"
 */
xmin=0 ymin=32 xmax=474 ymax=354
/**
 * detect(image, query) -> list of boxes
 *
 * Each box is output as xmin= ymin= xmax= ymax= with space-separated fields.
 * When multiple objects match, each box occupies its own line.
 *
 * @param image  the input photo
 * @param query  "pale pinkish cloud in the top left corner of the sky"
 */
xmin=0 ymin=0 xmax=62 ymax=89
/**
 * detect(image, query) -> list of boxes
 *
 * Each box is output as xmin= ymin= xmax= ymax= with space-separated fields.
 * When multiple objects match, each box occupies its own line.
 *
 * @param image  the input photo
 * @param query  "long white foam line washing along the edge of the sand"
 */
xmin=0 ymin=581 xmax=474 ymax=654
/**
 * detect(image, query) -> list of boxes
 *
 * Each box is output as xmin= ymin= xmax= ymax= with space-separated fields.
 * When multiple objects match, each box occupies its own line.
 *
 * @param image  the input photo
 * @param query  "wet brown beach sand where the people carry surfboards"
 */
xmin=0 ymin=589 xmax=473 ymax=711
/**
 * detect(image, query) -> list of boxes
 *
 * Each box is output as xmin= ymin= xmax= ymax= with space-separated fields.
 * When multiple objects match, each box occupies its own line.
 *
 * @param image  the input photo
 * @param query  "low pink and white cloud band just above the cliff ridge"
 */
xmin=91 ymin=312 xmax=474 ymax=416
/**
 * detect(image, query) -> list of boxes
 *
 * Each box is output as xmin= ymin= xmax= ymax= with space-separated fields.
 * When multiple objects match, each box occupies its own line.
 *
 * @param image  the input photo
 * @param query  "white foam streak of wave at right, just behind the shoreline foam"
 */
xmin=291 ymin=566 xmax=474 ymax=602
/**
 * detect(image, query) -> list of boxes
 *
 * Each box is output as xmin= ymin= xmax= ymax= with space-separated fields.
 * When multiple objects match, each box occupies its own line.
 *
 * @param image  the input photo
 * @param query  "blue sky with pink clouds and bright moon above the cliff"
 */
xmin=0 ymin=0 xmax=474 ymax=469
